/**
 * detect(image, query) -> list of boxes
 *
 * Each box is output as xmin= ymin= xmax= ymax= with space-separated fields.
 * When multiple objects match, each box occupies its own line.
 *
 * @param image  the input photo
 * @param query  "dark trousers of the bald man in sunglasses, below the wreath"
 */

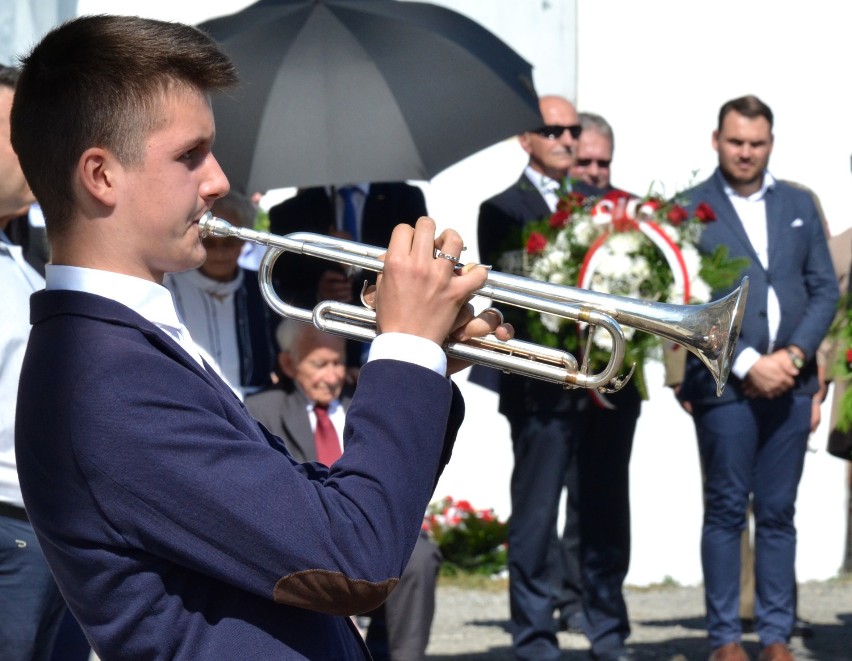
xmin=508 ymin=387 xmax=641 ymax=661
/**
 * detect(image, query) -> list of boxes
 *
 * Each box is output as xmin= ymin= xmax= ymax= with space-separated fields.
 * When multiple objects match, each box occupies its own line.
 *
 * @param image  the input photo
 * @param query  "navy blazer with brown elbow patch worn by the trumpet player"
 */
xmin=16 ymin=291 xmax=463 ymax=660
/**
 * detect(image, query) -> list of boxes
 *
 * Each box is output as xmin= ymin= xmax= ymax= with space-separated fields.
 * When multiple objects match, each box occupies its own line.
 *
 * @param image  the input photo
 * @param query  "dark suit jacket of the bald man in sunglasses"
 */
xmin=470 ymin=174 xmax=604 ymax=417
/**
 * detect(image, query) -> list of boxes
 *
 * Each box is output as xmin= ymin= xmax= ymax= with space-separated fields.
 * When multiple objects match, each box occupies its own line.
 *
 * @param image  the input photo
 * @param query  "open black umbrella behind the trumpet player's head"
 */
xmin=199 ymin=0 xmax=541 ymax=193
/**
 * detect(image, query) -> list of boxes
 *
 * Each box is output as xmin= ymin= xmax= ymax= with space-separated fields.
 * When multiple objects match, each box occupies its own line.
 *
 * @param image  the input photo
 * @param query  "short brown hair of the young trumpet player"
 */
xmin=11 ymin=15 xmax=237 ymax=240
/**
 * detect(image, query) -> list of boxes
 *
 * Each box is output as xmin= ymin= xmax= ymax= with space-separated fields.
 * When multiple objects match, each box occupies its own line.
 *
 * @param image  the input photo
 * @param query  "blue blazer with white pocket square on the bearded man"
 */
xmin=679 ymin=169 xmax=839 ymax=403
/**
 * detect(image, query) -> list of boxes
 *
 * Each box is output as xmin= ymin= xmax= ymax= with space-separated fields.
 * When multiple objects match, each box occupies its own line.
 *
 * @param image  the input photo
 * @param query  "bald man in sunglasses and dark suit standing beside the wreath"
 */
xmin=470 ymin=96 xmax=640 ymax=661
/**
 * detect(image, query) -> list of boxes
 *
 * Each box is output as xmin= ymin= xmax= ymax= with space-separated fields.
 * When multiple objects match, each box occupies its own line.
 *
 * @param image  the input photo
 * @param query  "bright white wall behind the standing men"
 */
xmin=48 ymin=0 xmax=852 ymax=584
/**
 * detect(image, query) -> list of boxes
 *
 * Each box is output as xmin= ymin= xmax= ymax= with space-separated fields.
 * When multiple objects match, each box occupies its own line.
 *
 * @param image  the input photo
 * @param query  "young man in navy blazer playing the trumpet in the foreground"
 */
xmin=11 ymin=15 xmax=511 ymax=661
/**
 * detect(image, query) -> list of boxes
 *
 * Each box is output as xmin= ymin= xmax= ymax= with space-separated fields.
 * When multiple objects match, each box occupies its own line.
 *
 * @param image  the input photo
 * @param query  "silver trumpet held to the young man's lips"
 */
xmin=199 ymin=212 xmax=748 ymax=395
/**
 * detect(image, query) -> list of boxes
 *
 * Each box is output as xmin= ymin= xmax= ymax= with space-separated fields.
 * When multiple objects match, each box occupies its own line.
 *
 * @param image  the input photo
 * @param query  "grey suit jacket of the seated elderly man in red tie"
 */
xmin=246 ymin=379 xmax=352 ymax=462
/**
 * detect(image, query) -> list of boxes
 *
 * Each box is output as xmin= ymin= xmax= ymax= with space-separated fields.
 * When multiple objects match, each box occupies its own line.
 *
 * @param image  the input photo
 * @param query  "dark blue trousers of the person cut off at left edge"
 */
xmin=0 ymin=516 xmax=66 ymax=661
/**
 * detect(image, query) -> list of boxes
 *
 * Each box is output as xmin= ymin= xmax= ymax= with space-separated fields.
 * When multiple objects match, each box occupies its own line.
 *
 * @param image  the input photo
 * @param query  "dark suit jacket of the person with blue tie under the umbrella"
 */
xmin=269 ymin=182 xmax=426 ymax=308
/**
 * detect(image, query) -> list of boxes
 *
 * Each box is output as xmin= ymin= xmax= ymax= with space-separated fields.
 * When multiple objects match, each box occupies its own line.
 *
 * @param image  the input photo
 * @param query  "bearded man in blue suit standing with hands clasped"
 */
xmin=678 ymin=96 xmax=838 ymax=661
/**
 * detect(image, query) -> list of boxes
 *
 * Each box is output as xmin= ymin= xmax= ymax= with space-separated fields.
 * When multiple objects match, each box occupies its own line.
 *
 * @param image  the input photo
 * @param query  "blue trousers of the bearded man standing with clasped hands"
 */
xmin=693 ymin=395 xmax=811 ymax=647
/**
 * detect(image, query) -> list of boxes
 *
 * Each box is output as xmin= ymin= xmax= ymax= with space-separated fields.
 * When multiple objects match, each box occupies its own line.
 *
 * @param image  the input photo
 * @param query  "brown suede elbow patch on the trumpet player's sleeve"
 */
xmin=272 ymin=569 xmax=399 ymax=616
